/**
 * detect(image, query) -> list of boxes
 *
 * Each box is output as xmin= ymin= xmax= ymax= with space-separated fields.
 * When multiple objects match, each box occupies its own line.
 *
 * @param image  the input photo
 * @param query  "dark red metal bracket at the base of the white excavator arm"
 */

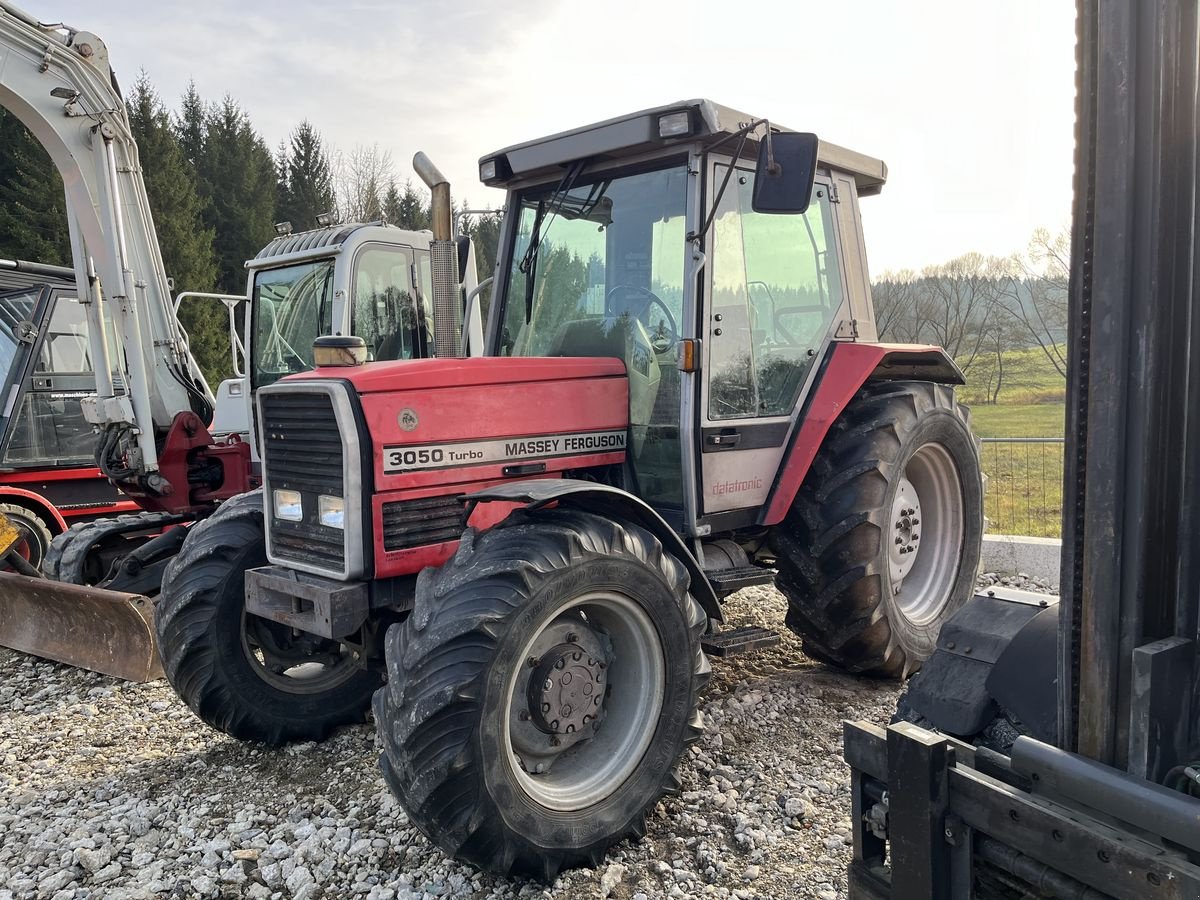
xmin=131 ymin=412 xmax=260 ymax=515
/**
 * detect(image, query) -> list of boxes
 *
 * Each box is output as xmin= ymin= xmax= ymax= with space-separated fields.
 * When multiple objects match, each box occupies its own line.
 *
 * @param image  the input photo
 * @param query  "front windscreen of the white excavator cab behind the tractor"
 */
xmin=251 ymin=259 xmax=334 ymax=388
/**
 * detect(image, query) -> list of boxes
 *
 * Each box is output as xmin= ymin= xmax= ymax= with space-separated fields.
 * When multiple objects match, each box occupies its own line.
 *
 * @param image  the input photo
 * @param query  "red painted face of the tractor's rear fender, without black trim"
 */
xmin=758 ymin=343 xmax=953 ymax=526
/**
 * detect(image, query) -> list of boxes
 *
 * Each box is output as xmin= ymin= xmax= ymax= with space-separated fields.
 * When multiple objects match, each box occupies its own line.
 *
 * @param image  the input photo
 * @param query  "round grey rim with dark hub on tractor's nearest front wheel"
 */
xmin=502 ymin=592 xmax=666 ymax=811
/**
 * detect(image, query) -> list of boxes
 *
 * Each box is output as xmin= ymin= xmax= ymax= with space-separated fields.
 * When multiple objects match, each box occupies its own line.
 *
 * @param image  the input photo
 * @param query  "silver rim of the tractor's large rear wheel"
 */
xmin=888 ymin=444 xmax=964 ymax=625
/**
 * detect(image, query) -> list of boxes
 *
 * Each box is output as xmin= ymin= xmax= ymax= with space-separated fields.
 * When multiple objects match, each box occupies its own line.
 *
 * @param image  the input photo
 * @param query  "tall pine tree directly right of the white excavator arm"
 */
xmin=128 ymin=72 xmax=232 ymax=385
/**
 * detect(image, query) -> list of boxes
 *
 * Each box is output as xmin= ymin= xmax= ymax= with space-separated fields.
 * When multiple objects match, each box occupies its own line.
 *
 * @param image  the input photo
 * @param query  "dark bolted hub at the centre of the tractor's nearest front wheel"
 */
xmin=511 ymin=618 xmax=610 ymax=774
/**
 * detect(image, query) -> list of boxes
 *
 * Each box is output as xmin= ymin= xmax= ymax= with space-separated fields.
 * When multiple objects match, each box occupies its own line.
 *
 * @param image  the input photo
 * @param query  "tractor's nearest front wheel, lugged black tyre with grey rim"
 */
xmin=374 ymin=510 xmax=709 ymax=880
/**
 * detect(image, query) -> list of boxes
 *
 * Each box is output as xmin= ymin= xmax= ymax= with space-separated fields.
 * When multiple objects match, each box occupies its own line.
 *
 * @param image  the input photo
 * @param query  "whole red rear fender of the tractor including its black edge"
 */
xmin=758 ymin=342 xmax=966 ymax=526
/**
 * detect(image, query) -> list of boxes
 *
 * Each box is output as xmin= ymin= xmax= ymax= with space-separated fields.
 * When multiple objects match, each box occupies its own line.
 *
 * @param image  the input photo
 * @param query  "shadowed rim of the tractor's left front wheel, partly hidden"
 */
xmin=241 ymin=612 xmax=360 ymax=694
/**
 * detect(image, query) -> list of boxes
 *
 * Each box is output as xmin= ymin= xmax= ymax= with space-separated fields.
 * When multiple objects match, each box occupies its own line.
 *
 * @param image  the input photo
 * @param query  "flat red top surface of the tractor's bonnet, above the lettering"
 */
xmin=319 ymin=356 xmax=625 ymax=394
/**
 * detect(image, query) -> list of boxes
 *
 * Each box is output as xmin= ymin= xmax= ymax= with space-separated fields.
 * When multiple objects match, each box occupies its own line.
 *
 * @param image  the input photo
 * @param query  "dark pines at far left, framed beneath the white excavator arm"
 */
xmin=0 ymin=109 xmax=71 ymax=265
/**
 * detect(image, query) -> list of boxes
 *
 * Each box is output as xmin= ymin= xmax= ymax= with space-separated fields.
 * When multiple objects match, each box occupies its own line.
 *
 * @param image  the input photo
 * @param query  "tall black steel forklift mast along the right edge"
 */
xmin=1058 ymin=0 xmax=1200 ymax=780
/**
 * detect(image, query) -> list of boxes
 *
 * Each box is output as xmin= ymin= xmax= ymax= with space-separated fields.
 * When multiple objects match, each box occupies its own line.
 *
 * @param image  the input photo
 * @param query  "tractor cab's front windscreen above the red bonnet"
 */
xmin=500 ymin=164 xmax=688 ymax=356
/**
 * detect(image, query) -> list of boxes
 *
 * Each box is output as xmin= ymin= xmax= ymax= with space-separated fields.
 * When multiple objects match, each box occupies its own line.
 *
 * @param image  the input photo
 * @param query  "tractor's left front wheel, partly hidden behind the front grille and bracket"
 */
xmin=155 ymin=490 xmax=380 ymax=746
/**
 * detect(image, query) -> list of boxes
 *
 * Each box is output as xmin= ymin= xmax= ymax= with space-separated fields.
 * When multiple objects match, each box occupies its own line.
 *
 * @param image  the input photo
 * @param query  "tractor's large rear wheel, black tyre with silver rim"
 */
xmin=772 ymin=382 xmax=983 ymax=678
